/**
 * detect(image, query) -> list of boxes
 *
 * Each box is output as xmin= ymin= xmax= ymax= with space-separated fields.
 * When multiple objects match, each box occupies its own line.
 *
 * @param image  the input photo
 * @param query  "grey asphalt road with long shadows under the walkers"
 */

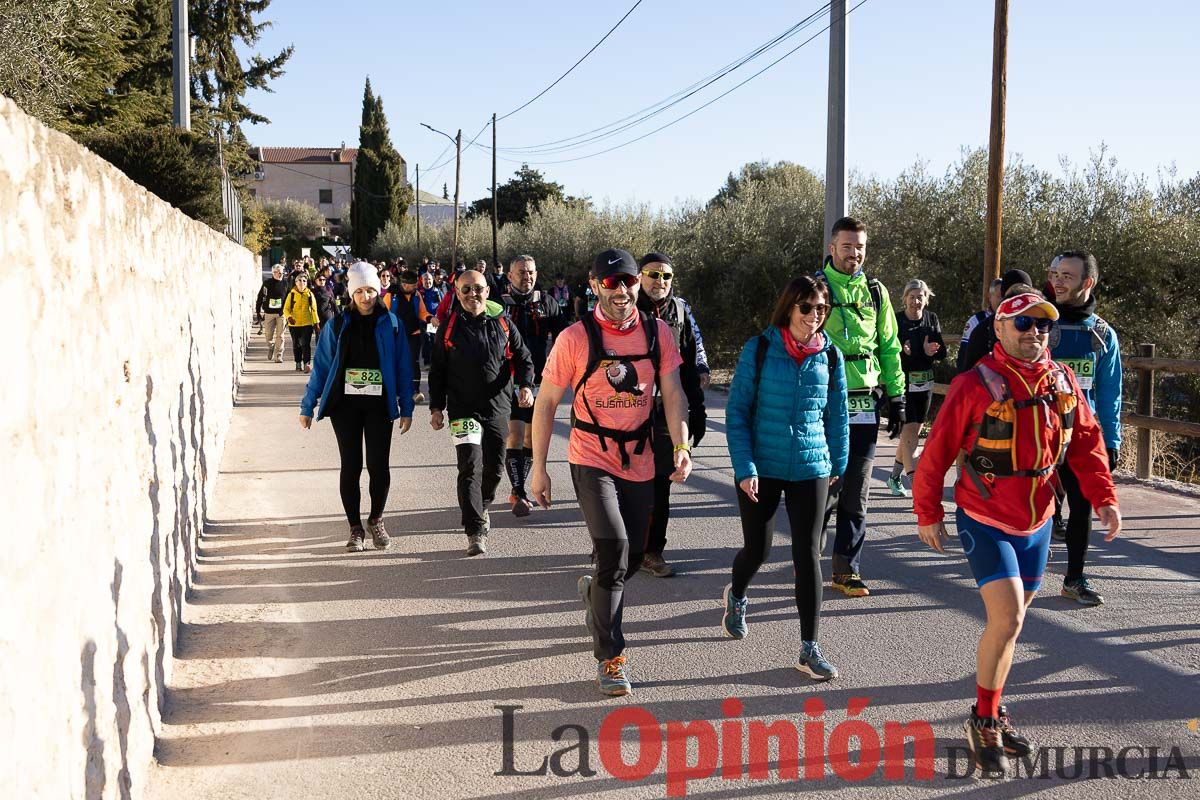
xmin=149 ymin=338 xmax=1200 ymax=800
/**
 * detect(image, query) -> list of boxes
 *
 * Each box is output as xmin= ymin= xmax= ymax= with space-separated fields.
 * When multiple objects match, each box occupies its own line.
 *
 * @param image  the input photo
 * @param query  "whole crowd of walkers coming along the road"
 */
xmin=256 ymin=217 xmax=1121 ymax=770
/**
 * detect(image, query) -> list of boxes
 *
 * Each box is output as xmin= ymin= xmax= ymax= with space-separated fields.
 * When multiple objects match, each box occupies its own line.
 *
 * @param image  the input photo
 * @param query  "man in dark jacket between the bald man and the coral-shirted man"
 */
xmin=499 ymin=255 xmax=559 ymax=517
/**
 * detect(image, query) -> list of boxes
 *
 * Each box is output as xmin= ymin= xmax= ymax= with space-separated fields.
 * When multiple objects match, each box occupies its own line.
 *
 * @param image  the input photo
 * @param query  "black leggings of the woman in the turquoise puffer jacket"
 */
xmin=733 ymin=477 xmax=829 ymax=642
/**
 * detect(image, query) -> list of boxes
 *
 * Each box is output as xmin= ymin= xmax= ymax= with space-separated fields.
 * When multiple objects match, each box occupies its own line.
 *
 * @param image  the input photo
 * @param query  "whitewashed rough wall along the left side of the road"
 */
xmin=0 ymin=97 xmax=260 ymax=800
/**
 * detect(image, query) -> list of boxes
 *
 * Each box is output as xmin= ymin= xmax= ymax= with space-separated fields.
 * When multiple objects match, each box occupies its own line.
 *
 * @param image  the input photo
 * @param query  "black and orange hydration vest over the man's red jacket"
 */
xmin=964 ymin=362 xmax=1079 ymax=500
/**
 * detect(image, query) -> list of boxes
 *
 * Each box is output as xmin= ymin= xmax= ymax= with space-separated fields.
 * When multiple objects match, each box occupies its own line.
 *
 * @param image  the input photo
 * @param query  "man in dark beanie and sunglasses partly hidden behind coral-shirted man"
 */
xmin=637 ymin=253 xmax=708 ymax=578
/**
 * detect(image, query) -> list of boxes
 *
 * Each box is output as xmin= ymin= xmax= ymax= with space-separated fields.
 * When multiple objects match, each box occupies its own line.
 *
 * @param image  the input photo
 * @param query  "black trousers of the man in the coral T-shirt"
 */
xmin=571 ymin=464 xmax=653 ymax=661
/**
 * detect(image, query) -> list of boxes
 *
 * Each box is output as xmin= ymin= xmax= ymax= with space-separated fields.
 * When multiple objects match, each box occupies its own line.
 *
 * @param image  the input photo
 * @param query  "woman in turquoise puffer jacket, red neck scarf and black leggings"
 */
xmin=721 ymin=276 xmax=850 ymax=680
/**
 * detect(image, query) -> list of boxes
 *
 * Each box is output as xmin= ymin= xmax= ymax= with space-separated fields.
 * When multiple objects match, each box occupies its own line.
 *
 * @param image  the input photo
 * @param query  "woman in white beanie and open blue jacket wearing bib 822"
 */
xmin=300 ymin=261 xmax=413 ymax=553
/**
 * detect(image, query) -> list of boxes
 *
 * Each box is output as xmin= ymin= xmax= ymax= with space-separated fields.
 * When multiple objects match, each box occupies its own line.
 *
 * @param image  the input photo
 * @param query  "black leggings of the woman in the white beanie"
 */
xmin=329 ymin=401 xmax=392 ymax=527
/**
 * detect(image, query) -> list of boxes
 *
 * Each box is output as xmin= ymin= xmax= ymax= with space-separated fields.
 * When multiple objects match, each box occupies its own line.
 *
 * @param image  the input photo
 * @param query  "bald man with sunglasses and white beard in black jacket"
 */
xmin=430 ymin=270 xmax=533 ymax=555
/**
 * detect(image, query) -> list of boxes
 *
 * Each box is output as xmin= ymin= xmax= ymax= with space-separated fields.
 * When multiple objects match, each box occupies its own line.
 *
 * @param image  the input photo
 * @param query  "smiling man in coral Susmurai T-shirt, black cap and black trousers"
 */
xmin=529 ymin=249 xmax=691 ymax=696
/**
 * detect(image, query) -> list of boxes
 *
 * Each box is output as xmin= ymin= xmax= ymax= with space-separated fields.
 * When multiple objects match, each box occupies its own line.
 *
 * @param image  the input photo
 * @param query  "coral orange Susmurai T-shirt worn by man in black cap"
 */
xmin=542 ymin=320 xmax=683 ymax=481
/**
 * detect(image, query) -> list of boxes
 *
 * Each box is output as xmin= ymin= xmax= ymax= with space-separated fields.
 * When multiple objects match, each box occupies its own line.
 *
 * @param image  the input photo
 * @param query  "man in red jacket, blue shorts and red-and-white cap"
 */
xmin=912 ymin=284 xmax=1121 ymax=772
